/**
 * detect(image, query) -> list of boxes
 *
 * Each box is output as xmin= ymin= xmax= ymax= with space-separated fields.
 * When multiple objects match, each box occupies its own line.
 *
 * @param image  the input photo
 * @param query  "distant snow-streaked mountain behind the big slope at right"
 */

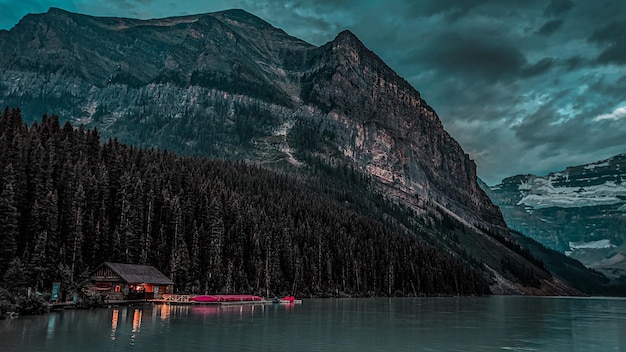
xmin=490 ymin=154 xmax=626 ymax=280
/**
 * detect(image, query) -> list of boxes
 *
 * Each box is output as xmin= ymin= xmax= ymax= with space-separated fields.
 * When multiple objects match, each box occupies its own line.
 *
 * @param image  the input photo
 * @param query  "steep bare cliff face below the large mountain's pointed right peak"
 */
xmin=301 ymin=31 xmax=506 ymax=232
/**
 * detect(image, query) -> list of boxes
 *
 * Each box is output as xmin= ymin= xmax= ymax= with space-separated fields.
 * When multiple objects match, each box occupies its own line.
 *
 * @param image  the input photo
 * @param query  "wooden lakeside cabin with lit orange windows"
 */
xmin=83 ymin=262 xmax=174 ymax=300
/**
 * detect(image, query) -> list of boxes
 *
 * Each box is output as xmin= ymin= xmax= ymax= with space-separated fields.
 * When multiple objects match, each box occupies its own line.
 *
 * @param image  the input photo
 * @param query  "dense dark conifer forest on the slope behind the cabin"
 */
xmin=0 ymin=110 xmax=489 ymax=296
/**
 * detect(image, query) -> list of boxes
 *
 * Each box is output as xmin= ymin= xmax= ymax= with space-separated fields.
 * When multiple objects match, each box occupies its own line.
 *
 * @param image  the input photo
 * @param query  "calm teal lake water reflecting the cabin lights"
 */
xmin=0 ymin=296 xmax=626 ymax=352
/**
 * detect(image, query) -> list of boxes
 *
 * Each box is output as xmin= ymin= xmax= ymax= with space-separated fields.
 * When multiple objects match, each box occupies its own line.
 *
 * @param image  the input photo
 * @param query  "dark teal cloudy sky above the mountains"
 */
xmin=0 ymin=0 xmax=626 ymax=184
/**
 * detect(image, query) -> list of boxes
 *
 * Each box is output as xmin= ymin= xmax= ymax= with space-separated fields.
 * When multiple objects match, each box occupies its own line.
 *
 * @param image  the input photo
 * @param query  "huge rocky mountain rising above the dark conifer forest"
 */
xmin=0 ymin=8 xmax=574 ymax=294
